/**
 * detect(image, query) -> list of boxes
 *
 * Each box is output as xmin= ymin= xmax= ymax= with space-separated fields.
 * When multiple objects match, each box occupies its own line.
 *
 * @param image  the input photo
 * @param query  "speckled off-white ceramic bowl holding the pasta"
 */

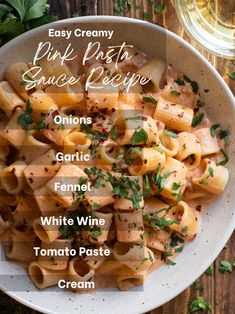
xmin=0 ymin=16 xmax=235 ymax=314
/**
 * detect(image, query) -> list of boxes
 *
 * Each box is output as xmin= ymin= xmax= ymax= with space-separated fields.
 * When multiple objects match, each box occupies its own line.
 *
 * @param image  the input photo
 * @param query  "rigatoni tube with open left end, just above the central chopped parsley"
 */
xmin=127 ymin=147 xmax=166 ymax=176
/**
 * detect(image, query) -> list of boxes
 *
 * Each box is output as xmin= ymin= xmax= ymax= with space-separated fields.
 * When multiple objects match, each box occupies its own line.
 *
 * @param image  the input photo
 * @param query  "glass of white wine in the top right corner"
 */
xmin=174 ymin=0 xmax=235 ymax=59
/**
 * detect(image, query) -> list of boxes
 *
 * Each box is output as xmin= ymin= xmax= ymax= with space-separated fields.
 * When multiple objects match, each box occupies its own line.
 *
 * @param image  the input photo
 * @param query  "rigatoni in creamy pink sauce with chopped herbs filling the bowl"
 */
xmin=0 ymin=47 xmax=229 ymax=293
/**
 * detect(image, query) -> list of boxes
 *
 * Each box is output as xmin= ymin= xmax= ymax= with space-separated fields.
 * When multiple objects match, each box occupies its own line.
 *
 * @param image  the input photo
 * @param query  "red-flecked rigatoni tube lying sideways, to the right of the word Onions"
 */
xmin=153 ymin=97 xmax=194 ymax=131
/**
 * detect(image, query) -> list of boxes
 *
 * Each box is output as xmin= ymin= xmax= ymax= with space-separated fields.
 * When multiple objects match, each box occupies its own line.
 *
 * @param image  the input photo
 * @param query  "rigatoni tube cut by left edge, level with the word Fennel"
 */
xmin=0 ymin=160 xmax=27 ymax=194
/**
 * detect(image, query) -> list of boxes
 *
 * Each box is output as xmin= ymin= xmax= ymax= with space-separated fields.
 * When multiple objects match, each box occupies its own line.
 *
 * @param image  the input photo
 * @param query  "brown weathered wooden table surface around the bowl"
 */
xmin=0 ymin=0 xmax=235 ymax=314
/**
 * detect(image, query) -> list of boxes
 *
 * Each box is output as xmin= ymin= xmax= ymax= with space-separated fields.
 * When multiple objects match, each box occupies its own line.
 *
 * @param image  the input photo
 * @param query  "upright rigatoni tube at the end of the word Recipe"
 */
xmin=138 ymin=58 xmax=166 ymax=92
